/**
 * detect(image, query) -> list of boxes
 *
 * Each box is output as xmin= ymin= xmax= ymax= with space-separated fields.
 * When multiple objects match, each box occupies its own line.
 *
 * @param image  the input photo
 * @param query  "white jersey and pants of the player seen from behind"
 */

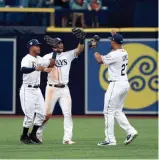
xmin=101 ymin=49 xmax=136 ymax=145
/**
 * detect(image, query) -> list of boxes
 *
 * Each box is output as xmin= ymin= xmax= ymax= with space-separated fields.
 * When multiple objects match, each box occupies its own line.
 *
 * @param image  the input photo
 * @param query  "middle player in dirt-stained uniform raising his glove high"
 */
xmin=37 ymin=28 xmax=85 ymax=144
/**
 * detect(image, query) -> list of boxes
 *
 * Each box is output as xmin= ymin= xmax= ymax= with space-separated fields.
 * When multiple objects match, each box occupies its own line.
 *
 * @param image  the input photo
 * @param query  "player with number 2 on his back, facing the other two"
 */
xmin=90 ymin=32 xmax=138 ymax=146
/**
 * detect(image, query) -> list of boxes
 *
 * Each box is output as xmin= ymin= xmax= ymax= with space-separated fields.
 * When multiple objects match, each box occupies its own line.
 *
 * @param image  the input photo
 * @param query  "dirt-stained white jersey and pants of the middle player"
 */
xmin=37 ymin=49 xmax=77 ymax=141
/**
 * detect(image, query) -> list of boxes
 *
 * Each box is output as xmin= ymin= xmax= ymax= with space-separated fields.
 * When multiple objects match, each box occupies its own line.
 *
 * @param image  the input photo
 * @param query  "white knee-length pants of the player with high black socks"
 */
xmin=20 ymin=85 xmax=46 ymax=128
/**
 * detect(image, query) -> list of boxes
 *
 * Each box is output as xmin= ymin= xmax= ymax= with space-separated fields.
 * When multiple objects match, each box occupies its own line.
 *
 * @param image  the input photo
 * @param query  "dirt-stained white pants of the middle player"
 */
xmin=37 ymin=85 xmax=73 ymax=141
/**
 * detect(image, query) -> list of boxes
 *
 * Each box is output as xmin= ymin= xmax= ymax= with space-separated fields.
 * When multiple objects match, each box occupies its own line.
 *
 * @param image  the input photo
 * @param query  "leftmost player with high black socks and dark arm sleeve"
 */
xmin=20 ymin=39 xmax=55 ymax=144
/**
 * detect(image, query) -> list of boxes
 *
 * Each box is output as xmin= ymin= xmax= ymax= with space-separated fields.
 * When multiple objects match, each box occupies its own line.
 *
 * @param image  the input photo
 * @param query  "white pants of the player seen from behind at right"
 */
xmin=103 ymin=81 xmax=135 ymax=143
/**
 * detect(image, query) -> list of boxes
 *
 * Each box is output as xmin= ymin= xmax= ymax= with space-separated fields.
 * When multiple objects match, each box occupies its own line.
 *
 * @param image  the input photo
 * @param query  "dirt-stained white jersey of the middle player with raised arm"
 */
xmin=43 ymin=49 xmax=77 ymax=84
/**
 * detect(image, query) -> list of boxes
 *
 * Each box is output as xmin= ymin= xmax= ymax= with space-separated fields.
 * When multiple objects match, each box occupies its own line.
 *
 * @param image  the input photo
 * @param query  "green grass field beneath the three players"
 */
xmin=0 ymin=118 xmax=158 ymax=159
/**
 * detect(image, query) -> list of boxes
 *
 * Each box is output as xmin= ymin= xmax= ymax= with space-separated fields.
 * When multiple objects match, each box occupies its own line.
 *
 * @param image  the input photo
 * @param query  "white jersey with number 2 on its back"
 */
xmin=101 ymin=49 xmax=128 ymax=81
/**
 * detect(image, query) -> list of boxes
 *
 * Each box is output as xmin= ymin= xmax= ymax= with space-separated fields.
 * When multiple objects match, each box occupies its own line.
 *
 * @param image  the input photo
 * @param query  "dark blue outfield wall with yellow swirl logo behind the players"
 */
xmin=0 ymin=29 xmax=158 ymax=115
